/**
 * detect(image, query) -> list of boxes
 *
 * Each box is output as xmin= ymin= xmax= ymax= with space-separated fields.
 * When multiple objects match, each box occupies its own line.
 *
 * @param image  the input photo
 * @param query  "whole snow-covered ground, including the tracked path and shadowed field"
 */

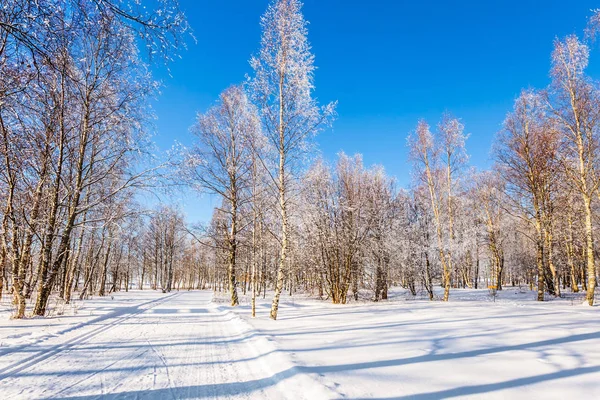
xmin=0 ymin=289 xmax=600 ymax=399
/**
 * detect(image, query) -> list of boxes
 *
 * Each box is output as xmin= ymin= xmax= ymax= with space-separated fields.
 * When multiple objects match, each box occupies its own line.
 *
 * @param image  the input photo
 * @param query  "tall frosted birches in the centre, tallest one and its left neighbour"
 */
xmin=184 ymin=0 xmax=335 ymax=319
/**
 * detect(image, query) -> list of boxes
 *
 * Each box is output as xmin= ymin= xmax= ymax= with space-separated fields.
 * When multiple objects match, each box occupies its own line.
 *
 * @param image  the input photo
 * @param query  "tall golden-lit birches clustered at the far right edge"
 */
xmin=496 ymin=32 xmax=600 ymax=305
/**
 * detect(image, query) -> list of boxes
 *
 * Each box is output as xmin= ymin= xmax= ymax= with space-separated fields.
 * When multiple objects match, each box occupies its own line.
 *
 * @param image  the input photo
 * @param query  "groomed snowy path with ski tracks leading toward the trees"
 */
xmin=0 ymin=292 xmax=331 ymax=399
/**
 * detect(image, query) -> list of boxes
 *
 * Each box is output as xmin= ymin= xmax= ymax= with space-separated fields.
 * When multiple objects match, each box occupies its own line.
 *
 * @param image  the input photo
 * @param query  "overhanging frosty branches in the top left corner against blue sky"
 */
xmin=0 ymin=0 xmax=190 ymax=67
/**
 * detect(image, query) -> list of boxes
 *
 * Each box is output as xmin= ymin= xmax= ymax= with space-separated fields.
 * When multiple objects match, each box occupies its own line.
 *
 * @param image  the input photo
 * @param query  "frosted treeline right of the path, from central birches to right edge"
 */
xmin=189 ymin=0 xmax=600 ymax=319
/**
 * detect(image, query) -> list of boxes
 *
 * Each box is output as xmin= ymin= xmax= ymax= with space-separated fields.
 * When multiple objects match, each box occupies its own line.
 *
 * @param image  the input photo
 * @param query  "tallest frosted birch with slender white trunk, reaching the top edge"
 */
xmin=250 ymin=0 xmax=334 ymax=319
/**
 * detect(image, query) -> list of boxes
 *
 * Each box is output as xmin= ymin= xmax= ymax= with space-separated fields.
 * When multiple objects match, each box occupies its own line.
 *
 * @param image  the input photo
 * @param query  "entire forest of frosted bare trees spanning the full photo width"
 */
xmin=0 ymin=0 xmax=600 ymax=319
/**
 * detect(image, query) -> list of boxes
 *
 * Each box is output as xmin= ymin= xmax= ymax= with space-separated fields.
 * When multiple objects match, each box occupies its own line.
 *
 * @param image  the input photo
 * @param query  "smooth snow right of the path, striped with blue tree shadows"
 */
xmin=225 ymin=288 xmax=600 ymax=399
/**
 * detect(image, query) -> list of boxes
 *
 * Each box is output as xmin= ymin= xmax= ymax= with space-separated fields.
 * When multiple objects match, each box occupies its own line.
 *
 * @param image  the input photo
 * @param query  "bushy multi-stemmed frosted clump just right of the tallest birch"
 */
xmin=300 ymin=153 xmax=403 ymax=304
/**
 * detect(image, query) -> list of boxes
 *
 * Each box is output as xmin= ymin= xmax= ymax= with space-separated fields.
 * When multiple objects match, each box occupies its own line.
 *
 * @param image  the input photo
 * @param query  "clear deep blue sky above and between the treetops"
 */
xmin=146 ymin=0 xmax=600 ymax=221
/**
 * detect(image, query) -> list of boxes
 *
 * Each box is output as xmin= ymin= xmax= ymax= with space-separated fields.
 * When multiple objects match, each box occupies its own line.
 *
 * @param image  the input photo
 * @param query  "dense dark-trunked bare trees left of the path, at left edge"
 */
xmin=0 ymin=0 xmax=192 ymax=318
